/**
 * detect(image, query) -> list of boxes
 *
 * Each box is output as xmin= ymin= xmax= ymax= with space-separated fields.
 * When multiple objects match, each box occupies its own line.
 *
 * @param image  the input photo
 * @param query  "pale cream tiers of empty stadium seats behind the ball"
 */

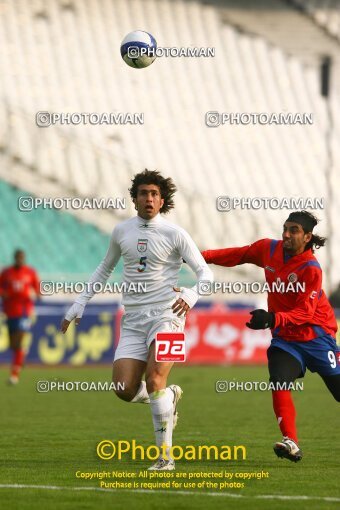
xmin=0 ymin=0 xmax=340 ymax=288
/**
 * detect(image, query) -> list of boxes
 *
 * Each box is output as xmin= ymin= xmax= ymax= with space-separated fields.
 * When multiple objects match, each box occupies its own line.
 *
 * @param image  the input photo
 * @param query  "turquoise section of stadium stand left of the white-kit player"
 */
xmin=0 ymin=181 xmax=109 ymax=275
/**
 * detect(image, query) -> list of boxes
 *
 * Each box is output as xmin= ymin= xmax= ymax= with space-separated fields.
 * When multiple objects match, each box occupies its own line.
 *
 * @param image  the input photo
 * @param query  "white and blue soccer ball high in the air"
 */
xmin=120 ymin=30 xmax=157 ymax=69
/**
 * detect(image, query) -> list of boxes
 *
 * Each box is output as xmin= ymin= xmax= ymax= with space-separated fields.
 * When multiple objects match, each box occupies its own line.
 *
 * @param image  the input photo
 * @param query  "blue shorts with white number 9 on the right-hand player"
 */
xmin=271 ymin=335 xmax=340 ymax=376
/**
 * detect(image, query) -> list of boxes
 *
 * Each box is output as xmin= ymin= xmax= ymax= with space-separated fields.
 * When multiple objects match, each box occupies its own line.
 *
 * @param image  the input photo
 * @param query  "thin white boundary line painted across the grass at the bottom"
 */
xmin=0 ymin=484 xmax=340 ymax=503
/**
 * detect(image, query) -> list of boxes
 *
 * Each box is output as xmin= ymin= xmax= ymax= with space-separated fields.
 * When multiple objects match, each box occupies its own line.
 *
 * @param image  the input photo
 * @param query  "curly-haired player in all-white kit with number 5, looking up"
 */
xmin=61 ymin=170 xmax=213 ymax=470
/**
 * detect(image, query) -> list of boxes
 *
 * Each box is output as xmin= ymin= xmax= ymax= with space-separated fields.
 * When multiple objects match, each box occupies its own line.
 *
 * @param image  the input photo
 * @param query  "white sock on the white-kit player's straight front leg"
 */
xmin=149 ymin=388 xmax=173 ymax=459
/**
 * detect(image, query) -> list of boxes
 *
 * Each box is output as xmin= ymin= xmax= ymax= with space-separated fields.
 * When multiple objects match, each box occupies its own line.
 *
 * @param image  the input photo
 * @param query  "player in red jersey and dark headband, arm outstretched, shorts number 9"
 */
xmin=202 ymin=211 xmax=340 ymax=462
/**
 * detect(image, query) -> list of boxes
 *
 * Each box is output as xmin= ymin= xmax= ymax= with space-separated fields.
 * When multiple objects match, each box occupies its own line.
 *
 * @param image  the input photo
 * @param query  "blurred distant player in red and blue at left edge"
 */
xmin=0 ymin=250 xmax=40 ymax=384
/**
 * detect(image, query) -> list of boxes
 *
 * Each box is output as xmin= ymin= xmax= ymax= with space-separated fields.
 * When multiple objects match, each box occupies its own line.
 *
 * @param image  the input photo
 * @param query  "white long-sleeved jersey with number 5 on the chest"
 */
xmin=76 ymin=214 xmax=213 ymax=309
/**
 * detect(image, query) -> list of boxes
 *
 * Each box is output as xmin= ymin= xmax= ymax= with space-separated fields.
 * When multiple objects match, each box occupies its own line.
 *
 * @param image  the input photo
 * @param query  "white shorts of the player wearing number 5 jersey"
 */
xmin=114 ymin=301 xmax=185 ymax=361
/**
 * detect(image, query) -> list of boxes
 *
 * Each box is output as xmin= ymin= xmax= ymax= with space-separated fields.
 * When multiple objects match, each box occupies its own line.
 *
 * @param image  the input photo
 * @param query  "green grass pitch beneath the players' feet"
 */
xmin=0 ymin=367 xmax=340 ymax=510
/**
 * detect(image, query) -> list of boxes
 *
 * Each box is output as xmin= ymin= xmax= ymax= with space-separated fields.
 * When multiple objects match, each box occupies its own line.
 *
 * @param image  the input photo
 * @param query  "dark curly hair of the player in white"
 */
xmin=129 ymin=169 xmax=177 ymax=214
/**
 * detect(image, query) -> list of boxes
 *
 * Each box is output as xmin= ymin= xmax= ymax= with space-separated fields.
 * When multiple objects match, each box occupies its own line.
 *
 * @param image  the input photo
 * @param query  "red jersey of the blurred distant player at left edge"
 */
xmin=0 ymin=266 xmax=40 ymax=319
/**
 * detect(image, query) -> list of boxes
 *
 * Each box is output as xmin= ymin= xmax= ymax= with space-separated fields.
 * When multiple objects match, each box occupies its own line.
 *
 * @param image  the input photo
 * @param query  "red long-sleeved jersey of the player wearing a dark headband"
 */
xmin=202 ymin=239 xmax=338 ymax=342
